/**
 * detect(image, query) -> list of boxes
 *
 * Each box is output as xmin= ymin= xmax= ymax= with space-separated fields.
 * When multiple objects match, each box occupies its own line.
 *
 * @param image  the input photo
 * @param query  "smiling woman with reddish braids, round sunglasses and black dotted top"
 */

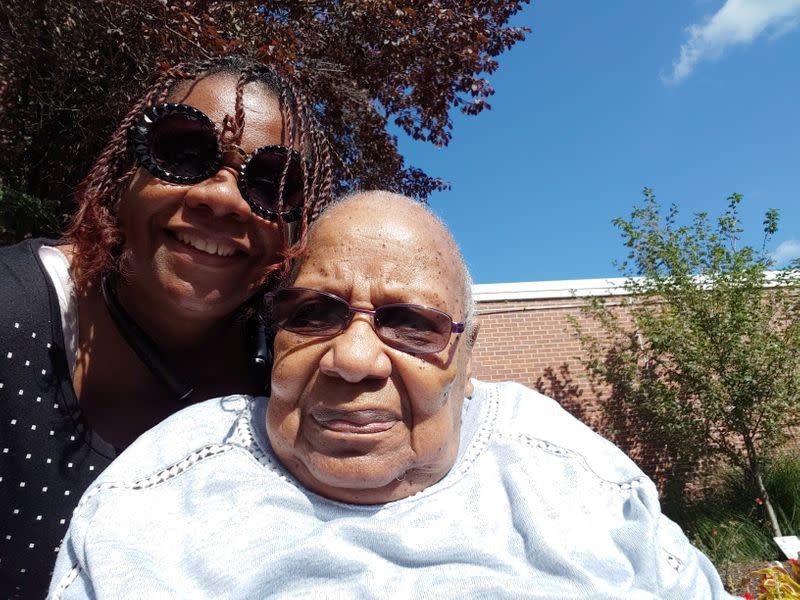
xmin=0 ymin=57 xmax=331 ymax=597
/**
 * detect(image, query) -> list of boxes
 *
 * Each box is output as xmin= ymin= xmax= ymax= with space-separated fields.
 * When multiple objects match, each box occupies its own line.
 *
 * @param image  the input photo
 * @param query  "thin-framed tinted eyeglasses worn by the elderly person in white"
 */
xmin=267 ymin=288 xmax=464 ymax=353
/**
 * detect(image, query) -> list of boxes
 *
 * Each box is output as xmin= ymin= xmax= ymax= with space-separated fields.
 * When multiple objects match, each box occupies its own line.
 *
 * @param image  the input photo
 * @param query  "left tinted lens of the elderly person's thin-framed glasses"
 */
xmin=272 ymin=288 xmax=350 ymax=336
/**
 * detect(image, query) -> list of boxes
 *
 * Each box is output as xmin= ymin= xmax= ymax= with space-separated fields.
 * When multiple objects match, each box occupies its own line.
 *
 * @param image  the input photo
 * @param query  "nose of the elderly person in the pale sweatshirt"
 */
xmin=320 ymin=316 xmax=392 ymax=383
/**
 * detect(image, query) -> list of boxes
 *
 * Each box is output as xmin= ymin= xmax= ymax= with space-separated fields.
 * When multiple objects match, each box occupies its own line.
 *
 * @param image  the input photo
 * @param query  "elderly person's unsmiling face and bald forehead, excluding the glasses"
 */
xmin=267 ymin=194 xmax=470 ymax=504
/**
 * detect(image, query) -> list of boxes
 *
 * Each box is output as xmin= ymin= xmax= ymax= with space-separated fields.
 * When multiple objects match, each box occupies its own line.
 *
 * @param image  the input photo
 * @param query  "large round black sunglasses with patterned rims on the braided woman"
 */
xmin=133 ymin=103 xmax=303 ymax=221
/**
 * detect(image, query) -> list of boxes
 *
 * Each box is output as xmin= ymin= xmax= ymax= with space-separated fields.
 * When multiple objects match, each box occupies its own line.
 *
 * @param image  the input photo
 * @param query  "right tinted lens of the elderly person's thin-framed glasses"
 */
xmin=375 ymin=304 xmax=452 ymax=352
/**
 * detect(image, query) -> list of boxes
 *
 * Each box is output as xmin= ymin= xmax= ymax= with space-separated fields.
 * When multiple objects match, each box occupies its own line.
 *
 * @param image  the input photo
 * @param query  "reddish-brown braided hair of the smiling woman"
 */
xmin=66 ymin=56 xmax=333 ymax=290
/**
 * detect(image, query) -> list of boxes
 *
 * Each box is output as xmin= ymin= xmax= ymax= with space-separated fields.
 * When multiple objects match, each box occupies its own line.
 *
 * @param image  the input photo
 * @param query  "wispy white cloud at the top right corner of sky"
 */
xmin=663 ymin=0 xmax=800 ymax=84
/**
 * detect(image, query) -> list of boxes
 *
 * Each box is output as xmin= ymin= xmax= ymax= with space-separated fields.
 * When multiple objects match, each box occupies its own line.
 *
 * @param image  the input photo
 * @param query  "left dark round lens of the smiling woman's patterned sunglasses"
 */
xmin=150 ymin=113 xmax=219 ymax=179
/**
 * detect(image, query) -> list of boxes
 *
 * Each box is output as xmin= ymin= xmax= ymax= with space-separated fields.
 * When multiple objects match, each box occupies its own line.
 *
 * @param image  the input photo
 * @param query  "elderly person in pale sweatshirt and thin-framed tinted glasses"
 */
xmin=45 ymin=193 xmax=726 ymax=600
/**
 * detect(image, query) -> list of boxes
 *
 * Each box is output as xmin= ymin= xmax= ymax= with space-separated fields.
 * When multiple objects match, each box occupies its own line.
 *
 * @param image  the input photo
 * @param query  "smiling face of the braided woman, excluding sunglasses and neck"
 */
xmin=118 ymin=74 xmax=286 ymax=319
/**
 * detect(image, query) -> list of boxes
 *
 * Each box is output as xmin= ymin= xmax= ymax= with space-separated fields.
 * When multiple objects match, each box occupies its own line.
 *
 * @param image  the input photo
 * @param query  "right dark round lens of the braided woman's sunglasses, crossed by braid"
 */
xmin=244 ymin=148 xmax=303 ymax=212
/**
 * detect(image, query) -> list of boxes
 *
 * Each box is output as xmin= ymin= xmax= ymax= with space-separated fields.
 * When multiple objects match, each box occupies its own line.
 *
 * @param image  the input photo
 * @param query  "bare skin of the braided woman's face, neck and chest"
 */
xmin=59 ymin=74 xmax=286 ymax=448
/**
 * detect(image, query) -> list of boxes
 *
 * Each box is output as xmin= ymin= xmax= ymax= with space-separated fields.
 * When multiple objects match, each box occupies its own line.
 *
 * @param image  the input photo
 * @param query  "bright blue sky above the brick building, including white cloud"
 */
xmin=400 ymin=0 xmax=800 ymax=283
